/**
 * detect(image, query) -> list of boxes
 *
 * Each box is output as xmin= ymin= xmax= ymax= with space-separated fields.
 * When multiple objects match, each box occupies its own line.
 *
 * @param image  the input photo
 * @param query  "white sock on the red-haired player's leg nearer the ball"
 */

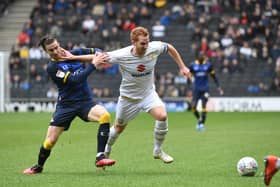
xmin=154 ymin=120 xmax=168 ymax=150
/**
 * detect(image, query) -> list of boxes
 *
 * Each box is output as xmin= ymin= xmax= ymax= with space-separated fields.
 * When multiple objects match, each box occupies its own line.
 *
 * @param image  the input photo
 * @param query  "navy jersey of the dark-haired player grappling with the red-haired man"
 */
xmin=47 ymin=48 xmax=100 ymax=104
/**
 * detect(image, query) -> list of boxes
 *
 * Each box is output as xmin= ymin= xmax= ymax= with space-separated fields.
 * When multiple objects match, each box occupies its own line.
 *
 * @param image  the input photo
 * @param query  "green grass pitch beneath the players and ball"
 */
xmin=0 ymin=112 xmax=280 ymax=187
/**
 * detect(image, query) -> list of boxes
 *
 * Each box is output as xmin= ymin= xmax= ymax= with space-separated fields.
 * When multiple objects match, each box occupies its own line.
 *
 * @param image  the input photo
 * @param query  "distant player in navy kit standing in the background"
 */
xmin=189 ymin=51 xmax=224 ymax=131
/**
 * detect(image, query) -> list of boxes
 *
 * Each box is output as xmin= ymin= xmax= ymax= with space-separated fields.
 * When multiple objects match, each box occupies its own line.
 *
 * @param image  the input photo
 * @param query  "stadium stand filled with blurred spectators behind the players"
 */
xmin=4 ymin=0 xmax=280 ymax=99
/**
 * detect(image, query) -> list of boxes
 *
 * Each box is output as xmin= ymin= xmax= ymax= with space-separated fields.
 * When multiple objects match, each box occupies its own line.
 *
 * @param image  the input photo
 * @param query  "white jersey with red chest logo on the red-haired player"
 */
xmin=108 ymin=41 xmax=168 ymax=99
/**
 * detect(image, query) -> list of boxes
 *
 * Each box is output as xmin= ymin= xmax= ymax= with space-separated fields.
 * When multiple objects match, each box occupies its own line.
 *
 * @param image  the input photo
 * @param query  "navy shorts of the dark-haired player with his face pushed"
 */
xmin=50 ymin=101 xmax=96 ymax=131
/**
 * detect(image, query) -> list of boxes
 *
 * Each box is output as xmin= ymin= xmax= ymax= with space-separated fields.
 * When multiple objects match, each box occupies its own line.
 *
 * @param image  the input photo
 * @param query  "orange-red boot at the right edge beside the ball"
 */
xmin=264 ymin=155 xmax=280 ymax=186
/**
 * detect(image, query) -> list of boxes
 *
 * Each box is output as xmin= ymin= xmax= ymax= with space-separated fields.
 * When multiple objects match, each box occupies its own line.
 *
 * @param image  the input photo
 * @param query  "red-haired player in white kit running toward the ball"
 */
xmin=105 ymin=27 xmax=191 ymax=163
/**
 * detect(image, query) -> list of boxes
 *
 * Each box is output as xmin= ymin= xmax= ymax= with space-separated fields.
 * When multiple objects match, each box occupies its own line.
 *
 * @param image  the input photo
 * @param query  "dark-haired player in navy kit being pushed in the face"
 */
xmin=23 ymin=36 xmax=115 ymax=174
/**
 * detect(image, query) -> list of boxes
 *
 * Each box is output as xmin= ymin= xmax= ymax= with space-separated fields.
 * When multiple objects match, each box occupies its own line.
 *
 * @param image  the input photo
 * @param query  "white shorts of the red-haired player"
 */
xmin=116 ymin=91 xmax=164 ymax=125
